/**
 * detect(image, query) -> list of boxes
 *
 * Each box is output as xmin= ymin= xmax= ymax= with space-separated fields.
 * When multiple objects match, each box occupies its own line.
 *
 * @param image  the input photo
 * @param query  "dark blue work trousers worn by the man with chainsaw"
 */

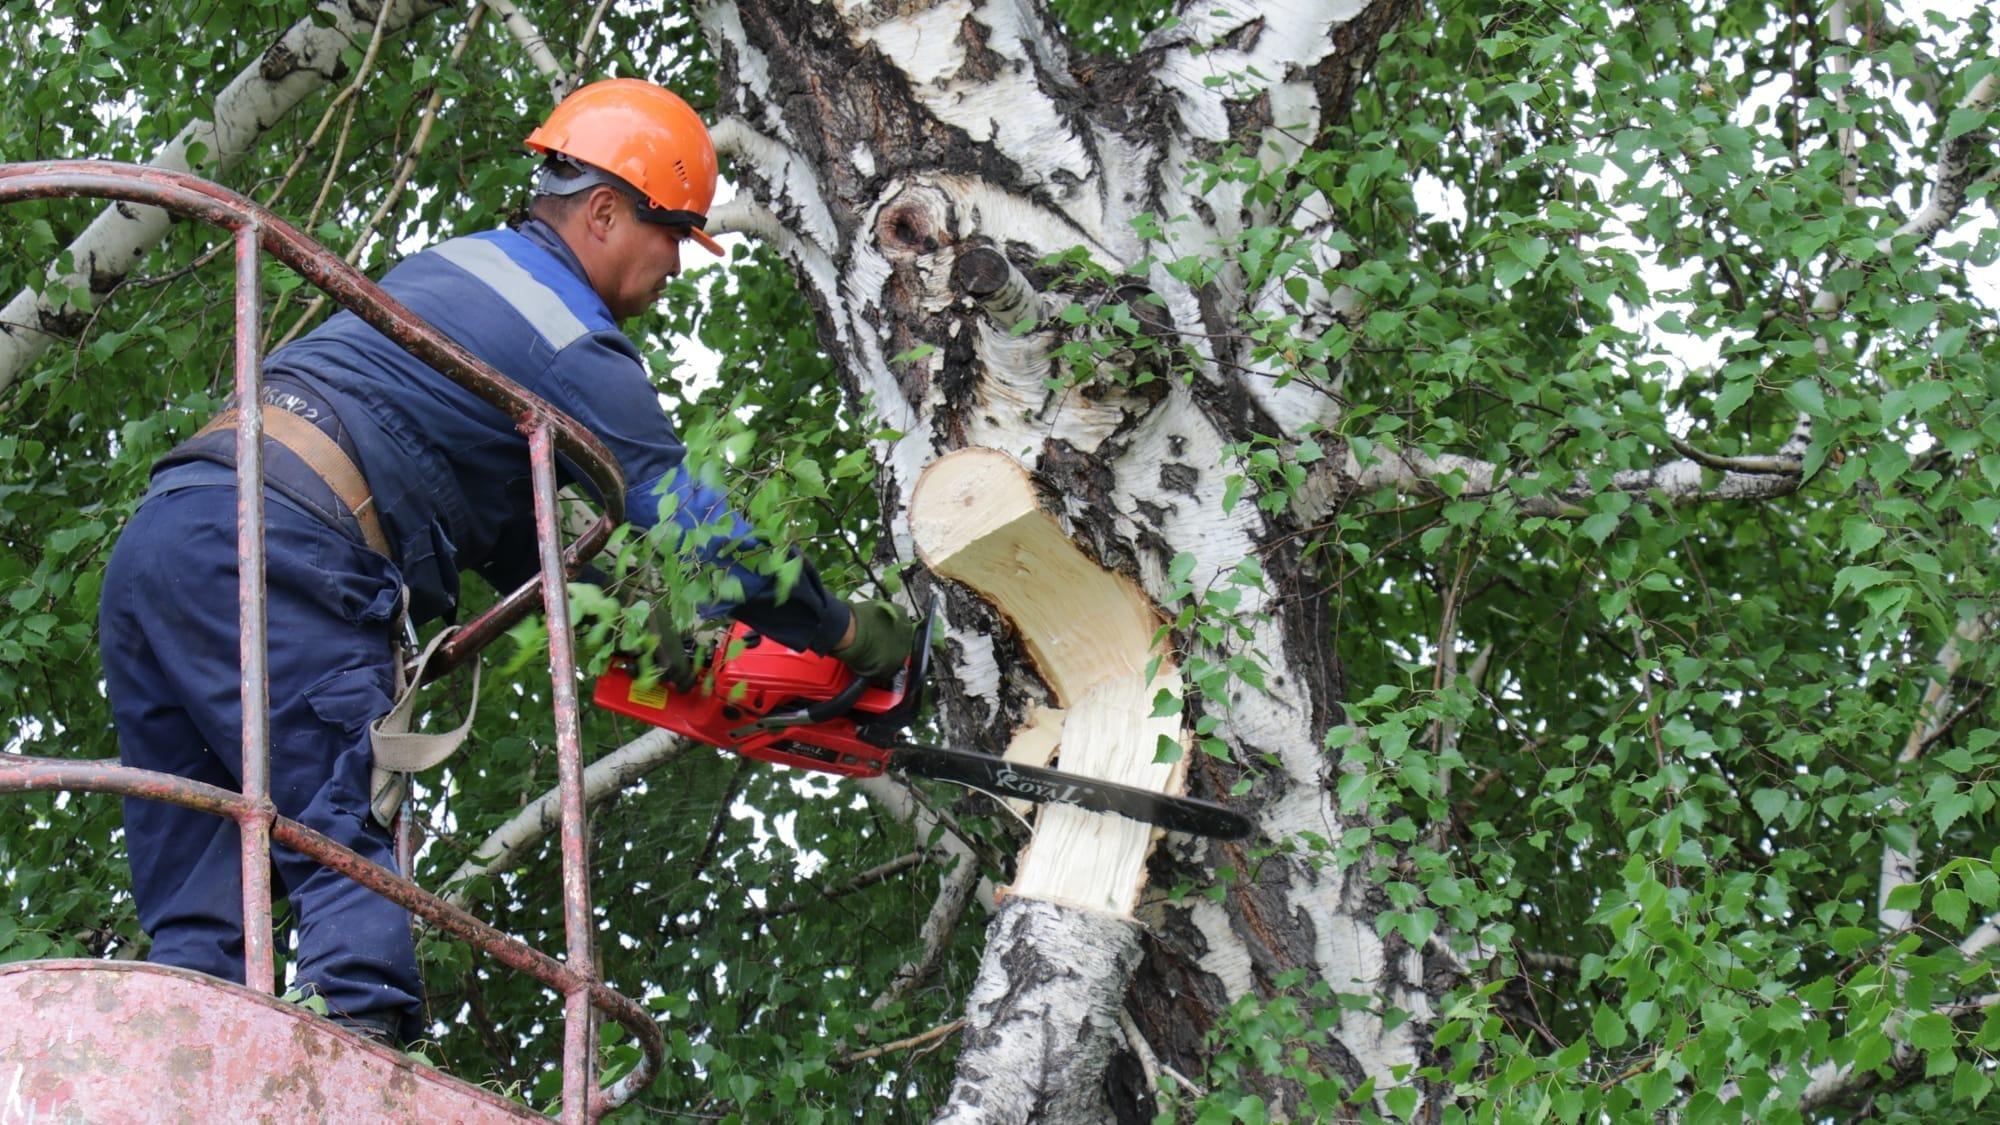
xmin=98 ymin=476 xmax=422 ymax=1035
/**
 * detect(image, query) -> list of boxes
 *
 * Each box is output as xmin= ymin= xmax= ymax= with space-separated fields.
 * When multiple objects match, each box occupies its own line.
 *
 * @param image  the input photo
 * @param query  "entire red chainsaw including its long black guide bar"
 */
xmin=592 ymin=611 xmax=1250 ymax=839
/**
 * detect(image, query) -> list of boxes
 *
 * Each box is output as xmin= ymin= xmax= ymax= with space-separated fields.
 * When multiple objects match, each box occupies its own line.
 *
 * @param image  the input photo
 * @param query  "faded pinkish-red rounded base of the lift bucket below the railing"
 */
xmin=0 ymin=961 xmax=546 ymax=1125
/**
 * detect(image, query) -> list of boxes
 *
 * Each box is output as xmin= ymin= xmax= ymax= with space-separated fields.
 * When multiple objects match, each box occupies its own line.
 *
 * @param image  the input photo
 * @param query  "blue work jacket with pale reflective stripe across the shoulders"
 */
xmin=225 ymin=220 xmax=850 ymax=653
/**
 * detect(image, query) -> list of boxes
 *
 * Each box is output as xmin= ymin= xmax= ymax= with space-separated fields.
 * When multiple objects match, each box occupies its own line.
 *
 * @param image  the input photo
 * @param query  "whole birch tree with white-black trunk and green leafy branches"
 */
xmin=0 ymin=0 xmax=2000 ymax=1121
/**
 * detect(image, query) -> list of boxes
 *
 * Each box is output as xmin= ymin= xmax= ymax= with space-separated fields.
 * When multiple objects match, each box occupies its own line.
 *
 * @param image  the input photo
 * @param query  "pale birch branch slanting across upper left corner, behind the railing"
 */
xmin=0 ymin=0 xmax=444 ymax=392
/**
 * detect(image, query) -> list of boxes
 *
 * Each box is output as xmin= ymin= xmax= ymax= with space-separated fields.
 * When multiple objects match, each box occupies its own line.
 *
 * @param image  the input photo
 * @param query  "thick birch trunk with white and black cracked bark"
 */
xmin=704 ymin=0 xmax=1462 ymax=1121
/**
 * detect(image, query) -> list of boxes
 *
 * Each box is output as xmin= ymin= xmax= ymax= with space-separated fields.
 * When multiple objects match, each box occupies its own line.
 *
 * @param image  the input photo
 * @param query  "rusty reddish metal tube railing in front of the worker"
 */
xmin=0 ymin=160 xmax=666 ymax=1123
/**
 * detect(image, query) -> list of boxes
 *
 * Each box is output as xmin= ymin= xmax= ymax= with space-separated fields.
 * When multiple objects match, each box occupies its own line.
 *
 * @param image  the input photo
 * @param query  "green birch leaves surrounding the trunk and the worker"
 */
xmin=0 ymin=0 xmax=2000 ymax=1123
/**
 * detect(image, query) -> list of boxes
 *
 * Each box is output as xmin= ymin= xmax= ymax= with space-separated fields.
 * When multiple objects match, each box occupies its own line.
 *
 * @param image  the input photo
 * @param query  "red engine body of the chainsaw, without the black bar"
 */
xmin=592 ymin=623 xmax=912 ymax=777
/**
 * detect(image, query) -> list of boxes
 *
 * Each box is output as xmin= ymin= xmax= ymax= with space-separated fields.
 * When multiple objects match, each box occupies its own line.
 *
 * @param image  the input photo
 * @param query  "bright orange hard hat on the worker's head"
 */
xmin=528 ymin=78 xmax=722 ymax=254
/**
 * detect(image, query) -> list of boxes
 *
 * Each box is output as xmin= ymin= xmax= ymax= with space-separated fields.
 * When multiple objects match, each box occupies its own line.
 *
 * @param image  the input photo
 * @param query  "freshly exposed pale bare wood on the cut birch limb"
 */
xmin=910 ymin=448 xmax=1186 ymax=917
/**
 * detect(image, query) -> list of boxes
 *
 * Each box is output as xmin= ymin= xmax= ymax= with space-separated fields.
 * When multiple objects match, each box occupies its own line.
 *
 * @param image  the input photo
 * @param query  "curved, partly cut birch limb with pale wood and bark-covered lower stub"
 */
xmin=910 ymin=448 xmax=1186 ymax=1123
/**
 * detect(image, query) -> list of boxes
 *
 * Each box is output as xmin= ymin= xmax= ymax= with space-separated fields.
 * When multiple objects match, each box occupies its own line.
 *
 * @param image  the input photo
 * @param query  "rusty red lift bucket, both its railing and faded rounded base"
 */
xmin=0 ymin=160 xmax=666 ymax=1125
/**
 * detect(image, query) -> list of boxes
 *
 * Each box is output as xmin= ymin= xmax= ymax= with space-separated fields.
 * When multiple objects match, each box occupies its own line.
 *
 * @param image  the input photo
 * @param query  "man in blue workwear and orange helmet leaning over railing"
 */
xmin=100 ymin=78 xmax=912 ymax=1039
